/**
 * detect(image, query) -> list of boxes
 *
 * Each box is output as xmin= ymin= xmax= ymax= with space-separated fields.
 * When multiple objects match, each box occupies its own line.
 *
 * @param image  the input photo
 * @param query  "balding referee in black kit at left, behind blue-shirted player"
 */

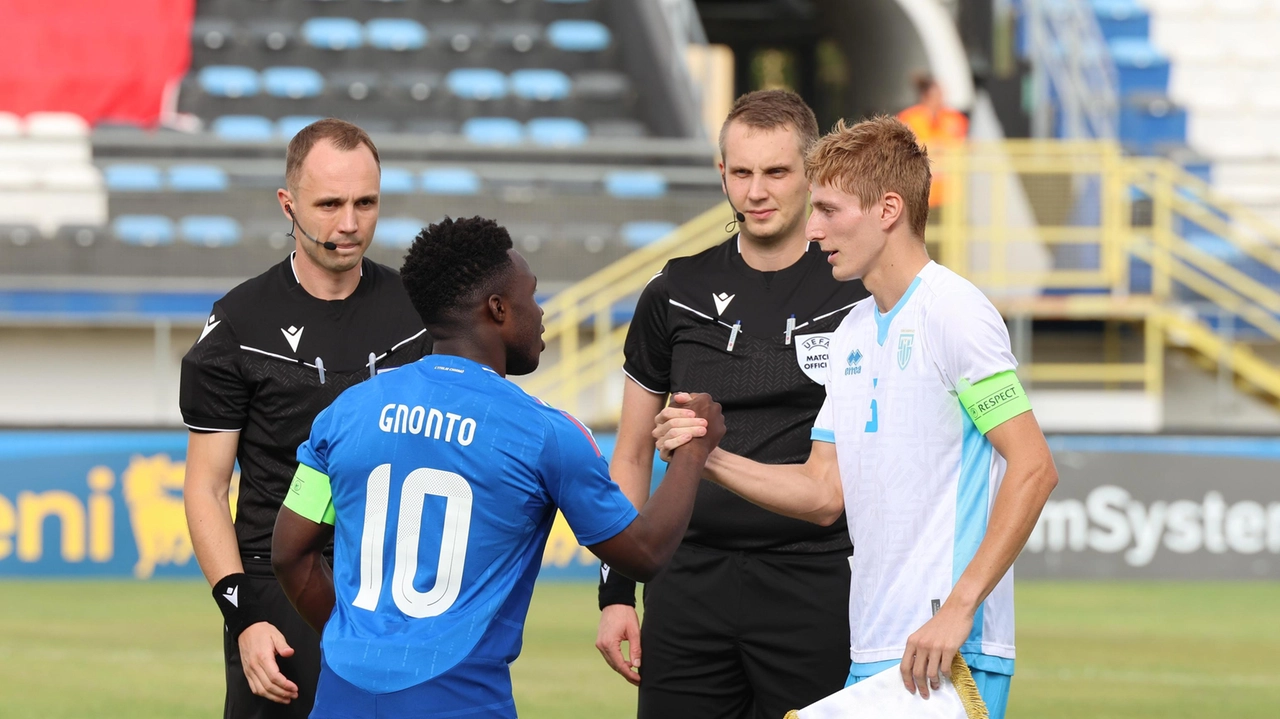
xmin=179 ymin=119 xmax=431 ymax=719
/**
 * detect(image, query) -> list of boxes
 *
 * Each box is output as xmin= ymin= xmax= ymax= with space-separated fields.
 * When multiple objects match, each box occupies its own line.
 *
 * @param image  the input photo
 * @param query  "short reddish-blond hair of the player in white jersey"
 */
xmin=804 ymin=115 xmax=932 ymax=238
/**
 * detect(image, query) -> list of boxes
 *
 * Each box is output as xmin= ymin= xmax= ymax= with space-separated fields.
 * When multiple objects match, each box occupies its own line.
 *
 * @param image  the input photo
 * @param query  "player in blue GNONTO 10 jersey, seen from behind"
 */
xmin=271 ymin=217 xmax=724 ymax=719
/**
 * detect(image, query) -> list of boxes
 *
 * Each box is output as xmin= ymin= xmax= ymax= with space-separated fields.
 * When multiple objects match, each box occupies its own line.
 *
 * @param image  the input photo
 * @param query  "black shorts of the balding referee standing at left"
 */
xmin=223 ymin=559 xmax=320 ymax=719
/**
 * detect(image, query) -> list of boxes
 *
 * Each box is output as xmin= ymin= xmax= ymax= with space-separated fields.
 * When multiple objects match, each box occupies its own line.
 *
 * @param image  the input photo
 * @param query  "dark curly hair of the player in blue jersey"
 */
xmin=401 ymin=212 xmax=513 ymax=325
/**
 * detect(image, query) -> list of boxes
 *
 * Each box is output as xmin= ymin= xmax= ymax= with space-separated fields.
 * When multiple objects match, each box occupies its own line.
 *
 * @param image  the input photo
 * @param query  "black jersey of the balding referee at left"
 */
xmin=179 ymin=255 xmax=431 ymax=559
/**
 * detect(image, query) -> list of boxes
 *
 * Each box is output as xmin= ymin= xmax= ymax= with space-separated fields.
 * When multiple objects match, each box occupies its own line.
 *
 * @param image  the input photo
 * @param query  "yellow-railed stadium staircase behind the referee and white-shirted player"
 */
xmin=524 ymin=141 xmax=1280 ymax=429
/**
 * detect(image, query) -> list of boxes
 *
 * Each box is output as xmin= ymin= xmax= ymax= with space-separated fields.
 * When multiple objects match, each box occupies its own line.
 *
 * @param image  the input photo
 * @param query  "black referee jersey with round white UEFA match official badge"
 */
xmin=623 ymin=237 xmax=868 ymax=551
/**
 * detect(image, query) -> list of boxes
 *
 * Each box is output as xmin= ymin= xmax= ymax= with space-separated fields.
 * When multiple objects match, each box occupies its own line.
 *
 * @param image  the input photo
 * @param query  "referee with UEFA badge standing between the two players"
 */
xmin=596 ymin=90 xmax=867 ymax=719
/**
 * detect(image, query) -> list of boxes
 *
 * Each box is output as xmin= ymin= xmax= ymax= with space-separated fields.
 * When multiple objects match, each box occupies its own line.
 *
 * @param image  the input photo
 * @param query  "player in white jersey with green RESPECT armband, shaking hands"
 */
xmin=654 ymin=118 xmax=1057 ymax=719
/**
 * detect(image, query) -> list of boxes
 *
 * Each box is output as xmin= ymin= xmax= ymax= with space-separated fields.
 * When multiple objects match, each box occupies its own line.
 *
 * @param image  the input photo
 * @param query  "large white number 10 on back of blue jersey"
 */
xmin=351 ymin=464 xmax=471 ymax=619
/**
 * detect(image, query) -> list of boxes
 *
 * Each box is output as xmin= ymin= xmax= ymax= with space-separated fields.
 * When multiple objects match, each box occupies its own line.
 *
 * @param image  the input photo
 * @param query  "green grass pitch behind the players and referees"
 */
xmin=0 ymin=581 xmax=1280 ymax=719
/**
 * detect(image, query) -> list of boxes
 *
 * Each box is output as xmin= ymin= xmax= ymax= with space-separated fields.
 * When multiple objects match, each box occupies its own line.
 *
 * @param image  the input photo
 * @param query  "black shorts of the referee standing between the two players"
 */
xmin=639 ymin=544 xmax=850 ymax=719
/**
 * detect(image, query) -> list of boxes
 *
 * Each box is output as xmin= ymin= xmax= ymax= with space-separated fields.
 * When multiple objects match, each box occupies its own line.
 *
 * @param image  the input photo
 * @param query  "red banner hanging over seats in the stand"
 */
xmin=0 ymin=0 xmax=196 ymax=127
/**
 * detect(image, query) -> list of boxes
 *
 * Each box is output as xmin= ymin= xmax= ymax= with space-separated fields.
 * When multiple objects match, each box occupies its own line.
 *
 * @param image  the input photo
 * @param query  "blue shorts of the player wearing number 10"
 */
xmin=311 ymin=656 xmax=516 ymax=719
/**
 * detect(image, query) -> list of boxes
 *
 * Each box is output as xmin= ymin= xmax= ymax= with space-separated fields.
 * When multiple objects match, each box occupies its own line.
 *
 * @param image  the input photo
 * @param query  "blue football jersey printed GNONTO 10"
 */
xmin=295 ymin=354 xmax=636 ymax=714
